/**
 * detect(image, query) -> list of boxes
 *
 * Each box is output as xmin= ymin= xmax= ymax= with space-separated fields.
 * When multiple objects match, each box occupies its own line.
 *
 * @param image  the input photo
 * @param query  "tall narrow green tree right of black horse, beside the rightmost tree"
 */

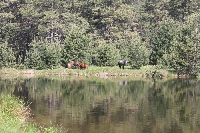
xmin=149 ymin=18 xmax=177 ymax=66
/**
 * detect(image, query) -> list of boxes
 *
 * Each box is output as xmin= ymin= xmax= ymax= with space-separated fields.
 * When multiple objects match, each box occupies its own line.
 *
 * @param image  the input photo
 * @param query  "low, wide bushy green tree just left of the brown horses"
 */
xmin=26 ymin=41 xmax=61 ymax=69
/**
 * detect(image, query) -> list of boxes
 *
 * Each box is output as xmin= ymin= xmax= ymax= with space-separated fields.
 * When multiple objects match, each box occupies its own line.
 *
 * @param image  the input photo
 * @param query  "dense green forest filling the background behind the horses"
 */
xmin=0 ymin=0 xmax=200 ymax=75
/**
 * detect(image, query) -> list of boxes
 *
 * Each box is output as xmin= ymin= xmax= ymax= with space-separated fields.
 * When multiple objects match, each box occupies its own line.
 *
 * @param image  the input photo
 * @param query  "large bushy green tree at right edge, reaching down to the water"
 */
xmin=171 ymin=23 xmax=200 ymax=75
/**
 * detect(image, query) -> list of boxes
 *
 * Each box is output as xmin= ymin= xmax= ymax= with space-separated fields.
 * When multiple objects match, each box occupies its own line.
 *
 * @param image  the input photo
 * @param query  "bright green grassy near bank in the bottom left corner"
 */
xmin=0 ymin=96 xmax=61 ymax=133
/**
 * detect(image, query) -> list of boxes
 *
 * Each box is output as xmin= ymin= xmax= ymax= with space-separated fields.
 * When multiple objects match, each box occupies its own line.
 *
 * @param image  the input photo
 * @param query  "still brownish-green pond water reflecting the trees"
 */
xmin=0 ymin=77 xmax=200 ymax=133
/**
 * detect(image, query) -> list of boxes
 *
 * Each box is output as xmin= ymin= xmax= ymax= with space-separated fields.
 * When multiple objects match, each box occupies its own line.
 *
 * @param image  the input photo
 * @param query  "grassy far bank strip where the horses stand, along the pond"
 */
xmin=0 ymin=66 xmax=180 ymax=78
